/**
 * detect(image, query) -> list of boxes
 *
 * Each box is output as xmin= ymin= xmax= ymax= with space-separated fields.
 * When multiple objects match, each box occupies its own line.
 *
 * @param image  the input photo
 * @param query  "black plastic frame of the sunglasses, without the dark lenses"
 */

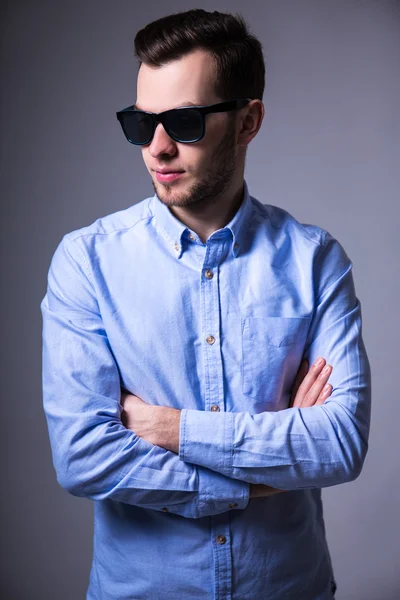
xmin=117 ymin=98 xmax=253 ymax=146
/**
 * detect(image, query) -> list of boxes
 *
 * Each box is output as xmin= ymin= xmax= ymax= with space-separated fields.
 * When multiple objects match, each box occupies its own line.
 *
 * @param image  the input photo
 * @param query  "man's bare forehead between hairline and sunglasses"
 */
xmin=135 ymin=50 xmax=219 ymax=112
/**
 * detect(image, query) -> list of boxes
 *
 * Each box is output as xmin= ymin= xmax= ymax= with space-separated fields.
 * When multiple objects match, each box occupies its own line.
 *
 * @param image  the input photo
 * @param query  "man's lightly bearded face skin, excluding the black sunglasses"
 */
xmin=136 ymin=51 xmax=238 ymax=207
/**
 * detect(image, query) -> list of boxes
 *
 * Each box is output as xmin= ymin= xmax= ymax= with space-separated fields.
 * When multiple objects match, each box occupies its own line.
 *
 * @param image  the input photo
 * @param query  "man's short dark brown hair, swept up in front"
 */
xmin=134 ymin=9 xmax=265 ymax=100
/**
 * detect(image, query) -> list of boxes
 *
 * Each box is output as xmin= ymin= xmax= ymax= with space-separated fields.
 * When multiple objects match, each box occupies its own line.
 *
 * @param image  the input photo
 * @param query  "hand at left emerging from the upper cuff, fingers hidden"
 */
xmin=121 ymin=391 xmax=181 ymax=454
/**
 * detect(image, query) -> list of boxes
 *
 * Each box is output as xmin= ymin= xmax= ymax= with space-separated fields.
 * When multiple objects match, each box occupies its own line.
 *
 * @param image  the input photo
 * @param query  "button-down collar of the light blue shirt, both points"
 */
xmin=150 ymin=180 xmax=253 ymax=258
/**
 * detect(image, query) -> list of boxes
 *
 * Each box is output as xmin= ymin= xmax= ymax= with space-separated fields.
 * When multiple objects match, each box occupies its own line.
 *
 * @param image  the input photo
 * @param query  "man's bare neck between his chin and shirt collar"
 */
xmin=169 ymin=179 xmax=244 ymax=243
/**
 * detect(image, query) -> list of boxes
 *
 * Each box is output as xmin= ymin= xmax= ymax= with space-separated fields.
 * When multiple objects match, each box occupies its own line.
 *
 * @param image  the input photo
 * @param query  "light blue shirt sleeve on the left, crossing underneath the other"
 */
xmin=40 ymin=234 xmax=249 ymax=518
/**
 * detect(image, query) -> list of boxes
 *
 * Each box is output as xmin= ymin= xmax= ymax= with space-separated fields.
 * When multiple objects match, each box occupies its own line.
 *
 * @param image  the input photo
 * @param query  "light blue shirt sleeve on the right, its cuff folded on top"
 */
xmin=179 ymin=232 xmax=371 ymax=490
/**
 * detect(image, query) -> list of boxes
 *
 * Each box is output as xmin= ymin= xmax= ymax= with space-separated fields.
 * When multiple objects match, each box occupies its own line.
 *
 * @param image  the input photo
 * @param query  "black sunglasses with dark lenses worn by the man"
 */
xmin=117 ymin=98 xmax=252 ymax=146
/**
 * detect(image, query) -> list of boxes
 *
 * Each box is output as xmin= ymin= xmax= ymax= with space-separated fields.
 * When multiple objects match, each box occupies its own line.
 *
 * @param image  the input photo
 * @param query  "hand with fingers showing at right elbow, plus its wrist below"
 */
xmin=250 ymin=357 xmax=332 ymax=498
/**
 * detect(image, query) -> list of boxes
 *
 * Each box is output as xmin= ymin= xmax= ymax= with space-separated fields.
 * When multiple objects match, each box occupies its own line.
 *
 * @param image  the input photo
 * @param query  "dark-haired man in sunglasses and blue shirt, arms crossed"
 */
xmin=41 ymin=10 xmax=370 ymax=600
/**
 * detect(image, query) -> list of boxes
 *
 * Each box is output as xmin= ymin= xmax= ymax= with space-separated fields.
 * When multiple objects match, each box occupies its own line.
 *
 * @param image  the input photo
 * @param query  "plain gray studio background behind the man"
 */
xmin=0 ymin=0 xmax=400 ymax=600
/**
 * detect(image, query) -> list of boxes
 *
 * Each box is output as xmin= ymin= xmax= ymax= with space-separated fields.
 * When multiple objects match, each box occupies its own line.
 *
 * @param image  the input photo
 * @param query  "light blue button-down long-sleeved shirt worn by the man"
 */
xmin=41 ymin=181 xmax=370 ymax=600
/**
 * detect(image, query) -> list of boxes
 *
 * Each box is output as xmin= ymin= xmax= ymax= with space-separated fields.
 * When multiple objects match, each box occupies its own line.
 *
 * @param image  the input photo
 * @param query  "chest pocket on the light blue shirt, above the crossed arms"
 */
xmin=241 ymin=316 xmax=310 ymax=409
